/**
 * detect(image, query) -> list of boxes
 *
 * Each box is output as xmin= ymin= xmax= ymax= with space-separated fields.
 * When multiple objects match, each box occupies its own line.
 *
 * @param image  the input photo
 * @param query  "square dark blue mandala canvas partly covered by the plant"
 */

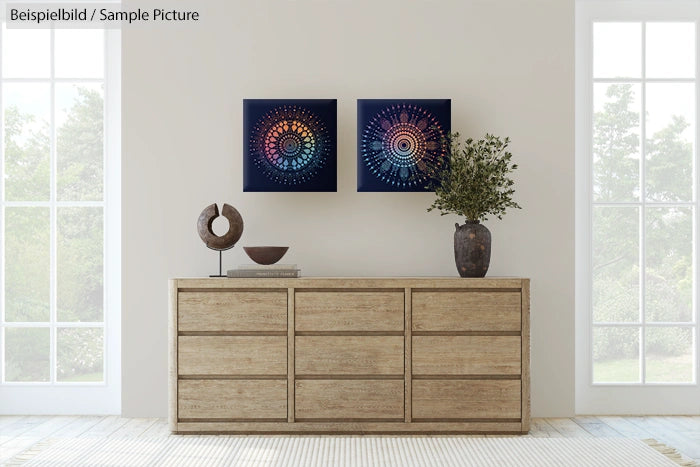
xmin=357 ymin=99 xmax=450 ymax=191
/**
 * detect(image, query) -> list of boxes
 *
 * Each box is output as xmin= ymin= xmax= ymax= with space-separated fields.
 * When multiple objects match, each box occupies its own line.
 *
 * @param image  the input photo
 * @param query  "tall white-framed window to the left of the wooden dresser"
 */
xmin=0 ymin=24 xmax=120 ymax=413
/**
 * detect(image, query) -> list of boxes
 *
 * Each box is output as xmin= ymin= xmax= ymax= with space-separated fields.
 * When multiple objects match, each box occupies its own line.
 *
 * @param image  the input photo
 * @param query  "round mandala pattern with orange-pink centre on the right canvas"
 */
xmin=360 ymin=104 xmax=447 ymax=189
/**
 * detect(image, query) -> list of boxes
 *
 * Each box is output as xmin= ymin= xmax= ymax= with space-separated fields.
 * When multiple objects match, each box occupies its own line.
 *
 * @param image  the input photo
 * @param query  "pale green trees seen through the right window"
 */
xmin=592 ymin=84 xmax=693 ymax=360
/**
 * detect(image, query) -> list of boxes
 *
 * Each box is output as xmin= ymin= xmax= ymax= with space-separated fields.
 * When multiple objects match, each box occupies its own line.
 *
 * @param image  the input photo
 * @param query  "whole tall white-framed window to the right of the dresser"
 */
xmin=576 ymin=1 xmax=700 ymax=413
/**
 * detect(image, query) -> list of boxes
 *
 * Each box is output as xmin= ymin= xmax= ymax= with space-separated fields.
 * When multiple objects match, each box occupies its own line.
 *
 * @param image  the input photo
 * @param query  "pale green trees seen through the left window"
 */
xmin=3 ymin=87 xmax=104 ymax=381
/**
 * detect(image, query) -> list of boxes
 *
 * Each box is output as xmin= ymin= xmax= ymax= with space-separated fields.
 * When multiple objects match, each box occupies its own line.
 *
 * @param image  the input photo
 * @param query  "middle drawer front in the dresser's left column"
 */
xmin=177 ymin=336 xmax=287 ymax=375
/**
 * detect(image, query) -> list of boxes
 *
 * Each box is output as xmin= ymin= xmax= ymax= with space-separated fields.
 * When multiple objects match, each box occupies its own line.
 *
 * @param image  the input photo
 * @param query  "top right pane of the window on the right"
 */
xmin=646 ymin=23 xmax=695 ymax=78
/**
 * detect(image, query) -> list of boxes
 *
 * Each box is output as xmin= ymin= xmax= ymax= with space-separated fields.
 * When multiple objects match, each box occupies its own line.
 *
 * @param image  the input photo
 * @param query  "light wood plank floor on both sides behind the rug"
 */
xmin=0 ymin=416 xmax=700 ymax=464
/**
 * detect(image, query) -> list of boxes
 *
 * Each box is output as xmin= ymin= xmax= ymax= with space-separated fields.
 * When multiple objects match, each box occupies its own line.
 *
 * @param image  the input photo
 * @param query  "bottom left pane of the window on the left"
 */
xmin=5 ymin=327 xmax=51 ymax=382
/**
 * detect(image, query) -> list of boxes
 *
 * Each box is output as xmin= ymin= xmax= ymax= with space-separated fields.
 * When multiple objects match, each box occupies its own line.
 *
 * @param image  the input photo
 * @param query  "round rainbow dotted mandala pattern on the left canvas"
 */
xmin=249 ymin=105 xmax=331 ymax=185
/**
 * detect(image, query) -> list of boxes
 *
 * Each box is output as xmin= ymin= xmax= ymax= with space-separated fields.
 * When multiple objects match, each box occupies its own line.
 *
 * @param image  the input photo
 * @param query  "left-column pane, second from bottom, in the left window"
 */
xmin=5 ymin=207 xmax=50 ymax=321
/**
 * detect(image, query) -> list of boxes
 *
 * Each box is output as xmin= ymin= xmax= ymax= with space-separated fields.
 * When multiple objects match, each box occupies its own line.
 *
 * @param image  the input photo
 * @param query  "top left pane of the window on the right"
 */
xmin=593 ymin=23 xmax=642 ymax=78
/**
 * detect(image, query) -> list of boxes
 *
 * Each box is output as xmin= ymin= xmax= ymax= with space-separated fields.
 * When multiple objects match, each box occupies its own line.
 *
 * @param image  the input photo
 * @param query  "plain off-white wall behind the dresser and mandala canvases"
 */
xmin=122 ymin=0 xmax=574 ymax=417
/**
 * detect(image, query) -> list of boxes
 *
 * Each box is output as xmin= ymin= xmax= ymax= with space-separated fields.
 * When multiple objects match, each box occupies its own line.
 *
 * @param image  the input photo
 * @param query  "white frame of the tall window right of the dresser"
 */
xmin=575 ymin=0 xmax=700 ymax=415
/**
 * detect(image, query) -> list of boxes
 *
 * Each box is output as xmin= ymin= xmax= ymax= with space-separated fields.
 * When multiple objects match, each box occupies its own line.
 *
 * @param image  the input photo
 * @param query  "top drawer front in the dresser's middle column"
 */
xmin=294 ymin=291 xmax=404 ymax=331
